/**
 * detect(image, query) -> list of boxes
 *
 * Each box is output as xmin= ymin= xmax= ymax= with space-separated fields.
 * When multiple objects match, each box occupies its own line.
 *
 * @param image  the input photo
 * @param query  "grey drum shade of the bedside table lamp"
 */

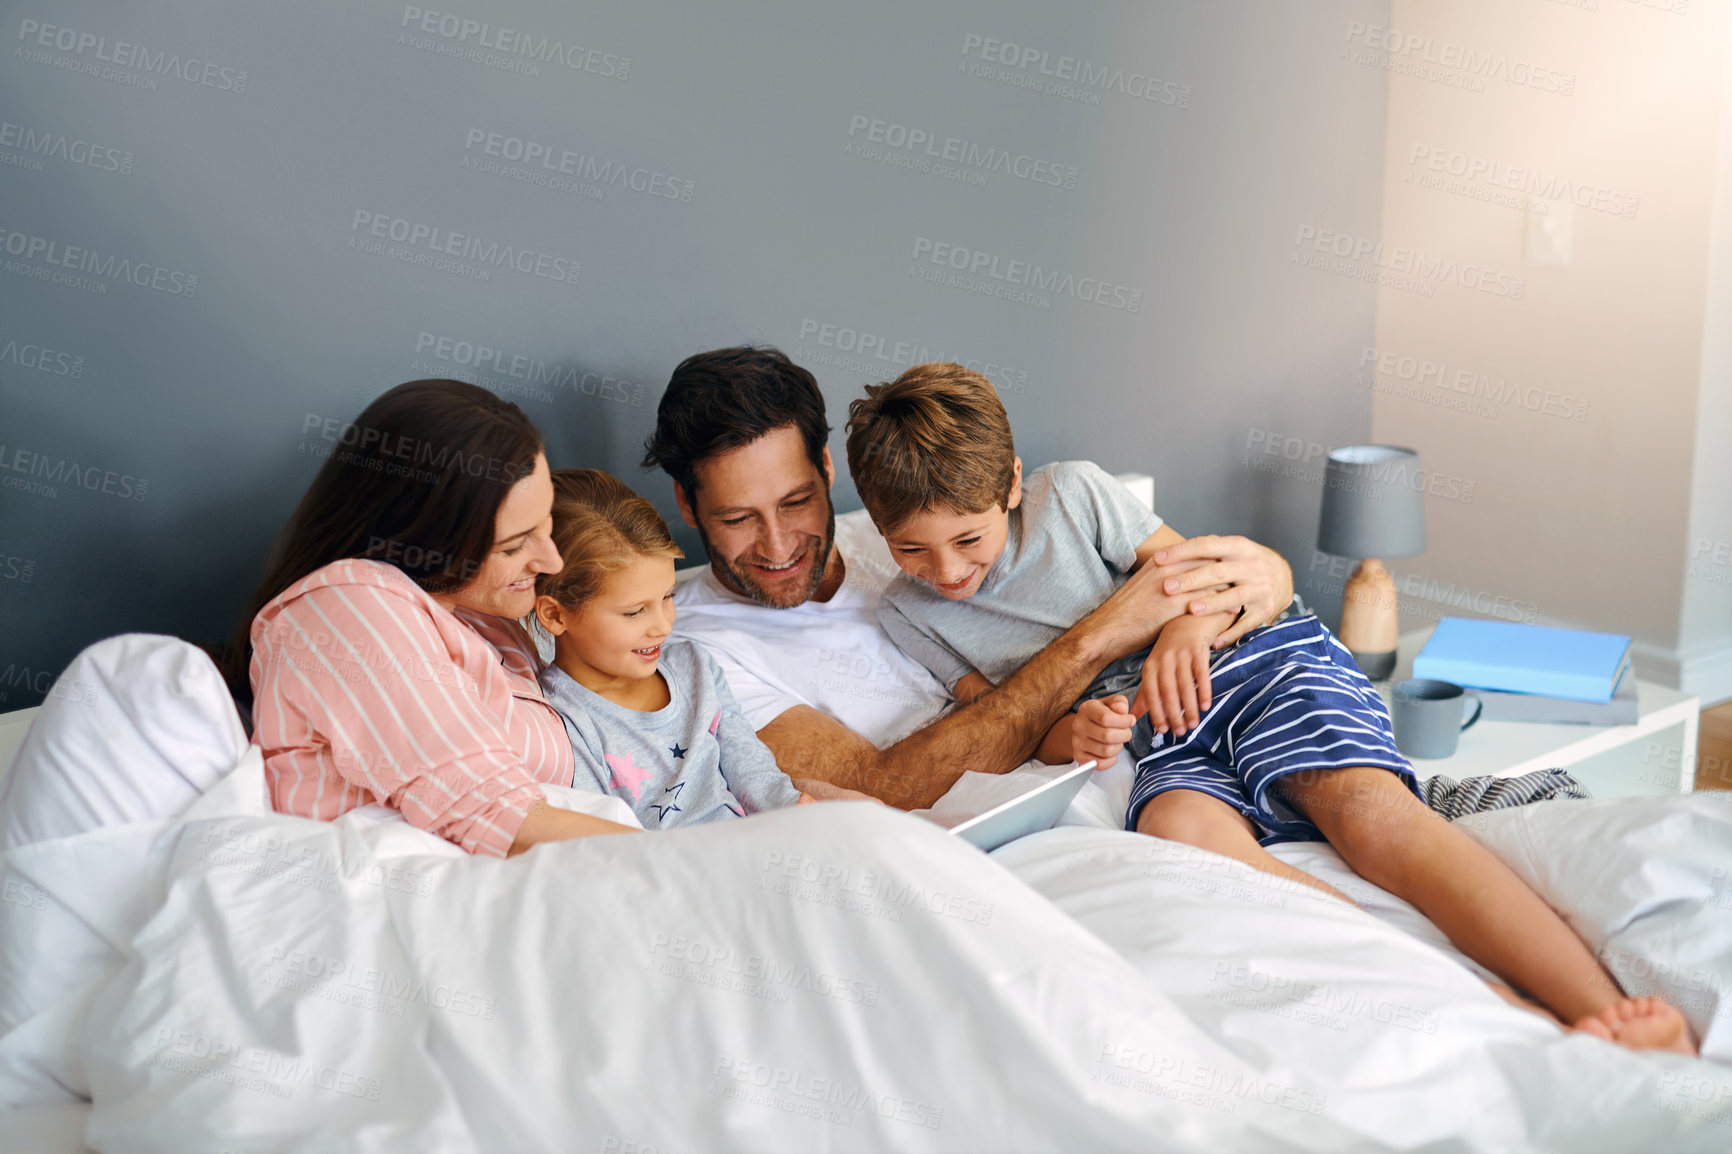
xmin=1316 ymin=445 xmax=1425 ymax=558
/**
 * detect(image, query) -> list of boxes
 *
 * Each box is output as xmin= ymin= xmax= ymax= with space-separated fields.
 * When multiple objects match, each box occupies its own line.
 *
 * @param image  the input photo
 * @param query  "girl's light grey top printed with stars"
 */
xmin=540 ymin=639 xmax=800 ymax=830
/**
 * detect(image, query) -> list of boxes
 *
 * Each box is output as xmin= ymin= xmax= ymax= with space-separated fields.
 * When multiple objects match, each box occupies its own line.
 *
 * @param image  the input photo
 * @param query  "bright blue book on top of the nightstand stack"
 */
xmin=1413 ymin=617 xmax=1630 ymax=702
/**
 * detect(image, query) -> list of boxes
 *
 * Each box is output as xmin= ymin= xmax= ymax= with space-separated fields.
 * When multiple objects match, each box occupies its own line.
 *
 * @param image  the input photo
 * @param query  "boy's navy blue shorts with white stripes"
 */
xmin=1124 ymin=613 xmax=1424 ymax=846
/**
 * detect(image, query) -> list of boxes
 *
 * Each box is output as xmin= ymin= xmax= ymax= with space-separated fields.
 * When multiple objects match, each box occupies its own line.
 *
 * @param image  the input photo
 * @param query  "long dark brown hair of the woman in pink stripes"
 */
xmin=223 ymin=379 xmax=542 ymax=706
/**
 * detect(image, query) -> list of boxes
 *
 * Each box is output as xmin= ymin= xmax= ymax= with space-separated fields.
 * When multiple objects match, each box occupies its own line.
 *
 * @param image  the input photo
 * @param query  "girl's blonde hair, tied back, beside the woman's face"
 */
xmin=535 ymin=470 xmax=686 ymax=606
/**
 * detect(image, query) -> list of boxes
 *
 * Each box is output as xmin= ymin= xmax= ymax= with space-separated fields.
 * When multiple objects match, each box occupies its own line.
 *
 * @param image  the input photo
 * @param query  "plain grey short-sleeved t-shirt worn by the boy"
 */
xmin=878 ymin=461 xmax=1160 ymax=700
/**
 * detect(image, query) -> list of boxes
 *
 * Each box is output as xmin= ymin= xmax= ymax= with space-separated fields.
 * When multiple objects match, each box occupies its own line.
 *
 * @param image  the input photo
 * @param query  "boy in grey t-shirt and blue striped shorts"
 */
xmin=849 ymin=364 xmax=1696 ymax=1054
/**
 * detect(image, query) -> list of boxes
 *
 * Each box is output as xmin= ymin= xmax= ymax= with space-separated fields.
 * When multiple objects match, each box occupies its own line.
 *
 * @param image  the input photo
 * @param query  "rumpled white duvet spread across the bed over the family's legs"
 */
xmin=0 ymin=754 xmax=1732 ymax=1154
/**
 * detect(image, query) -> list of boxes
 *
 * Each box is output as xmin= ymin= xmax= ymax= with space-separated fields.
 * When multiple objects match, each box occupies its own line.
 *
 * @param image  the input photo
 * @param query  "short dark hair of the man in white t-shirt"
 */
xmin=644 ymin=347 xmax=830 ymax=501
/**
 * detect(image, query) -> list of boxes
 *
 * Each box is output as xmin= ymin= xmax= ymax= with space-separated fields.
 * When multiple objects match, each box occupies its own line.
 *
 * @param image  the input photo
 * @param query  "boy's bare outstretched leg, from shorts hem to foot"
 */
xmin=1275 ymin=768 xmax=1696 ymax=1054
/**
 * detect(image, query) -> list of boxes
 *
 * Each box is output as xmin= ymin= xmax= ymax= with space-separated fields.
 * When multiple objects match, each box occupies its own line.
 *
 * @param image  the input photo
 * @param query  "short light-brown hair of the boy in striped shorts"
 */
xmin=849 ymin=360 xmax=1017 ymax=532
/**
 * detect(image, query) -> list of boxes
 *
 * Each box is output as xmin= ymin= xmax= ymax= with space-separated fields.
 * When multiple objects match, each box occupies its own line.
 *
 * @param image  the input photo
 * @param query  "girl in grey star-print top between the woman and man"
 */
xmin=535 ymin=470 xmax=848 ymax=830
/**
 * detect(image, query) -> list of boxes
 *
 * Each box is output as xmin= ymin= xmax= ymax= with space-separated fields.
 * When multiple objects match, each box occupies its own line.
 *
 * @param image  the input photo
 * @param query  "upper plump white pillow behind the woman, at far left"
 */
xmin=0 ymin=632 xmax=246 ymax=853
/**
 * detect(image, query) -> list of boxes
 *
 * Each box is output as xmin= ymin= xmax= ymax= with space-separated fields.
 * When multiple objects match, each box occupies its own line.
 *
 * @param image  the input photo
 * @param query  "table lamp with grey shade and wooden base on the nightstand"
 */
xmin=1316 ymin=445 xmax=1425 ymax=681
